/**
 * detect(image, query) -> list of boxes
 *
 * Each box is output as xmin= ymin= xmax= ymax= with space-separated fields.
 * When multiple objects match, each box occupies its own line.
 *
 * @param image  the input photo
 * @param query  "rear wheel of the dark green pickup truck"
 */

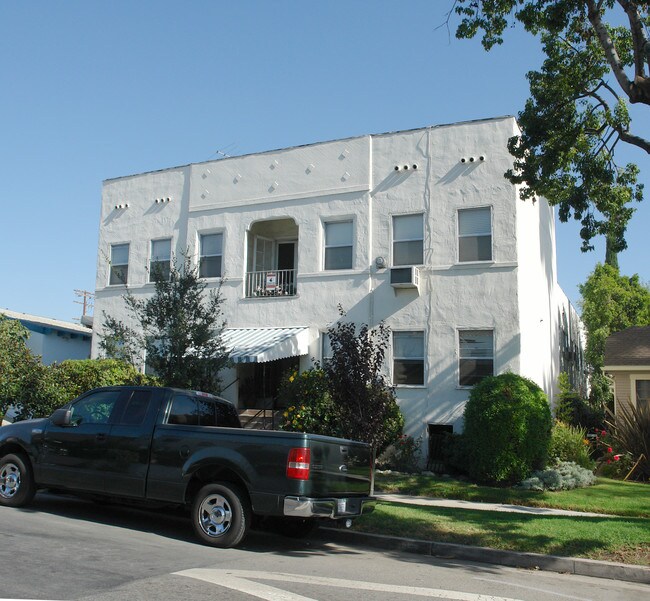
xmin=192 ymin=482 xmax=251 ymax=549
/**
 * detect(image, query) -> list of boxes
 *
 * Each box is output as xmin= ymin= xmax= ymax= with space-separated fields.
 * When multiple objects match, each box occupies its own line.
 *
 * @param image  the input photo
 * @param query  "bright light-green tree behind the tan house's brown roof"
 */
xmin=580 ymin=264 xmax=650 ymax=371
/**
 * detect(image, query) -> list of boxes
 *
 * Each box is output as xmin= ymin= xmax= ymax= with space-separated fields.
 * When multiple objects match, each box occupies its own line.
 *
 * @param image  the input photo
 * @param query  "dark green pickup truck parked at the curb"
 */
xmin=0 ymin=386 xmax=374 ymax=547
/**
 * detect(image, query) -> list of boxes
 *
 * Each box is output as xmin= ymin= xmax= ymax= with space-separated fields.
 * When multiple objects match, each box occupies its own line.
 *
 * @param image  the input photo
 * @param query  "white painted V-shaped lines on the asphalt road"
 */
xmin=174 ymin=568 xmax=520 ymax=601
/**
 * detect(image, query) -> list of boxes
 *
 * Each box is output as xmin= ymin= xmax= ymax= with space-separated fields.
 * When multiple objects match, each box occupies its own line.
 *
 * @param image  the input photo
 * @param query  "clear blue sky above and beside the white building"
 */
xmin=0 ymin=0 xmax=650 ymax=321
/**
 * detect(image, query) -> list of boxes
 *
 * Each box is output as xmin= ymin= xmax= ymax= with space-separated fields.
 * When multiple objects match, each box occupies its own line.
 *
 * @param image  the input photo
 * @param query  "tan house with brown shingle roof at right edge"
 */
xmin=603 ymin=326 xmax=650 ymax=410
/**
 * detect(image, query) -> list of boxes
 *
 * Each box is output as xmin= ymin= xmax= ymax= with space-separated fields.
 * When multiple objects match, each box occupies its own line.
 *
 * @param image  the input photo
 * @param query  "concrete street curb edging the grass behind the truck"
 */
xmin=321 ymin=527 xmax=650 ymax=584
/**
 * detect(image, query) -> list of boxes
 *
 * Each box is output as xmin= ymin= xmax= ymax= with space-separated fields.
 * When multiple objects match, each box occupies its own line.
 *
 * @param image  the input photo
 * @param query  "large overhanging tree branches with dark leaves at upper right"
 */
xmin=450 ymin=0 xmax=650 ymax=255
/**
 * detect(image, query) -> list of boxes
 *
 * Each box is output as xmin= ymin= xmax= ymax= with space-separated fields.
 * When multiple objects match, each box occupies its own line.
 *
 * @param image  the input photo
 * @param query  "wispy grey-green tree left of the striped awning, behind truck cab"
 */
xmin=99 ymin=257 xmax=228 ymax=393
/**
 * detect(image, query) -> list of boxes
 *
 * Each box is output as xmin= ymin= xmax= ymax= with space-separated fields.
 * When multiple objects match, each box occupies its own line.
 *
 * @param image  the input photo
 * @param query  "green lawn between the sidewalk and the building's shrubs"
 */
xmin=375 ymin=474 xmax=650 ymax=518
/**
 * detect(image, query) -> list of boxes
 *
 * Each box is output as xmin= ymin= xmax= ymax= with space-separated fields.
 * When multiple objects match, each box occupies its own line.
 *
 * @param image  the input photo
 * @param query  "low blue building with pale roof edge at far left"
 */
xmin=0 ymin=309 xmax=92 ymax=365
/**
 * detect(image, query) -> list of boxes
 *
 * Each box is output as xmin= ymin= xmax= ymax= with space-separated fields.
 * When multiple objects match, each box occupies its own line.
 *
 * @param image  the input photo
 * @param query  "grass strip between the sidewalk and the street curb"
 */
xmin=353 ymin=502 xmax=650 ymax=565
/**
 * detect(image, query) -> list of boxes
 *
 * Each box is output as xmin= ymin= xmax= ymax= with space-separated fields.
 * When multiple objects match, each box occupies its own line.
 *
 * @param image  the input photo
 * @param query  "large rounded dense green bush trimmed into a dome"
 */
xmin=463 ymin=373 xmax=552 ymax=483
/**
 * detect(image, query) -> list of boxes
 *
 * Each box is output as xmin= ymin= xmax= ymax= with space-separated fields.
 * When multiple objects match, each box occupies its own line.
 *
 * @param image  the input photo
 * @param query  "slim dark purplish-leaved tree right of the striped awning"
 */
xmin=323 ymin=306 xmax=404 ymax=453
